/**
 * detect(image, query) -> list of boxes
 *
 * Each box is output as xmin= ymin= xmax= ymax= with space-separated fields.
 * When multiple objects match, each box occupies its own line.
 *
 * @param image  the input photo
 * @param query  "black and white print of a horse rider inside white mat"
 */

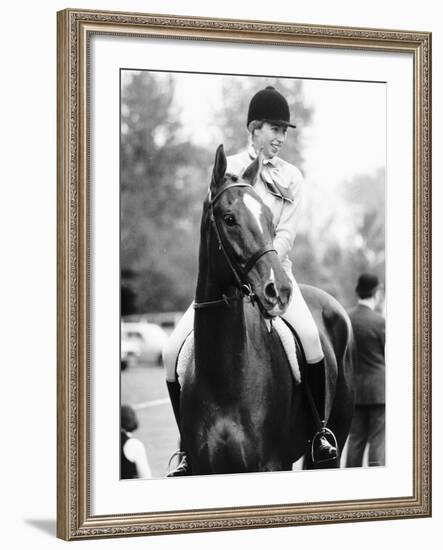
xmin=120 ymin=68 xmax=389 ymax=479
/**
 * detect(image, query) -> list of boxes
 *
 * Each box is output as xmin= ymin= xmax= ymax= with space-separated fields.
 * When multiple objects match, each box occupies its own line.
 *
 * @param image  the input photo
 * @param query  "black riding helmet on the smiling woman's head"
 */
xmin=246 ymin=86 xmax=296 ymax=128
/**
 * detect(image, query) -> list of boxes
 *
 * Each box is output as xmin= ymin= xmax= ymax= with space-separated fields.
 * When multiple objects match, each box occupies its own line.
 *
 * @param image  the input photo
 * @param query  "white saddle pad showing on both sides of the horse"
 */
xmin=177 ymin=317 xmax=303 ymax=387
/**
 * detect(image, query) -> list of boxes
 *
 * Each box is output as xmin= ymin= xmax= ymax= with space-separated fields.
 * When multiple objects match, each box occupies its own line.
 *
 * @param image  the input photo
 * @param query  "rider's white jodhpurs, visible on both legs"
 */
xmin=163 ymin=273 xmax=324 ymax=382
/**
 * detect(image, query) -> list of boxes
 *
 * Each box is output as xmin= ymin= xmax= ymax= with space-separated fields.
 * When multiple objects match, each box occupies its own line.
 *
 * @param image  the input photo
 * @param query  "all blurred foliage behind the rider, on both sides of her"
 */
xmin=121 ymin=71 xmax=385 ymax=315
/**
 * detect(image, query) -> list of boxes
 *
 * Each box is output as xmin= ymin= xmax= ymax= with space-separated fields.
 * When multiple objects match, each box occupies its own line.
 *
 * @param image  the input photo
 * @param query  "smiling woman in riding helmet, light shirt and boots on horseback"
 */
xmin=163 ymin=86 xmax=337 ymax=476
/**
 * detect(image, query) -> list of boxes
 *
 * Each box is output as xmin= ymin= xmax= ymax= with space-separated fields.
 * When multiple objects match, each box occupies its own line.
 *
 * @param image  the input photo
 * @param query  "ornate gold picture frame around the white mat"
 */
xmin=57 ymin=9 xmax=431 ymax=540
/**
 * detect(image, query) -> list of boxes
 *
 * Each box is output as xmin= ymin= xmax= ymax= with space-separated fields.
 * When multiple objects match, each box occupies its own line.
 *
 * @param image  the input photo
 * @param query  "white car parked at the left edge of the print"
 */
xmin=121 ymin=322 xmax=168 ymax=369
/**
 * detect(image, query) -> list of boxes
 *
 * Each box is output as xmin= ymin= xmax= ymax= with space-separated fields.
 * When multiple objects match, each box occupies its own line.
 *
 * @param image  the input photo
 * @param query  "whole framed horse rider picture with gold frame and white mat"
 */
xmin=57 ymin=9 xmax=431 ymax=540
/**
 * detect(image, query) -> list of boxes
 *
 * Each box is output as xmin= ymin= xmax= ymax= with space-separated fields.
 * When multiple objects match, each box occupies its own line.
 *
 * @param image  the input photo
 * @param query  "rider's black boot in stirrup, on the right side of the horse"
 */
xmin=306 ymin=359 xmax=337 ymax=464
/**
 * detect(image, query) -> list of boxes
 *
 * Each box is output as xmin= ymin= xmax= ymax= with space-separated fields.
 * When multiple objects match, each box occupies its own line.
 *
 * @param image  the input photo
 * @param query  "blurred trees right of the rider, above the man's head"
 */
xmin=290 ymin=169 xmax=385 ymax=307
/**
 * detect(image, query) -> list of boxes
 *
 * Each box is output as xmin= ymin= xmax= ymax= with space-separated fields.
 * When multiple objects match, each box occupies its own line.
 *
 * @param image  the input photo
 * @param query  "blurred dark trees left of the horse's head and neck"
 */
xmin=120 ymin=72 xmax=210 ymax=312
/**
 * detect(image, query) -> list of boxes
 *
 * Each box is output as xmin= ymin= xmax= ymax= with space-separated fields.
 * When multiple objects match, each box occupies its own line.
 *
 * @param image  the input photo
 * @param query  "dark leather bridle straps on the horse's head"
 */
xmin=194 ymin=182 xmax=277 ymax=309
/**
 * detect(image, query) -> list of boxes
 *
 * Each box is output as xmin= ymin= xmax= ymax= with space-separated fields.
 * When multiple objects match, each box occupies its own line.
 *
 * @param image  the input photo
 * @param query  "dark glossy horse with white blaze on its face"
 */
xmin=181 ymin=146 xmax=353 ymax=474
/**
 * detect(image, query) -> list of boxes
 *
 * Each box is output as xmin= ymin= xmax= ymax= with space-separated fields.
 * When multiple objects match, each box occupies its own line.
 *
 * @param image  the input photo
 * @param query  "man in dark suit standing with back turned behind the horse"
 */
xmin=346 ymin=273 xmax=385 ymax=468
